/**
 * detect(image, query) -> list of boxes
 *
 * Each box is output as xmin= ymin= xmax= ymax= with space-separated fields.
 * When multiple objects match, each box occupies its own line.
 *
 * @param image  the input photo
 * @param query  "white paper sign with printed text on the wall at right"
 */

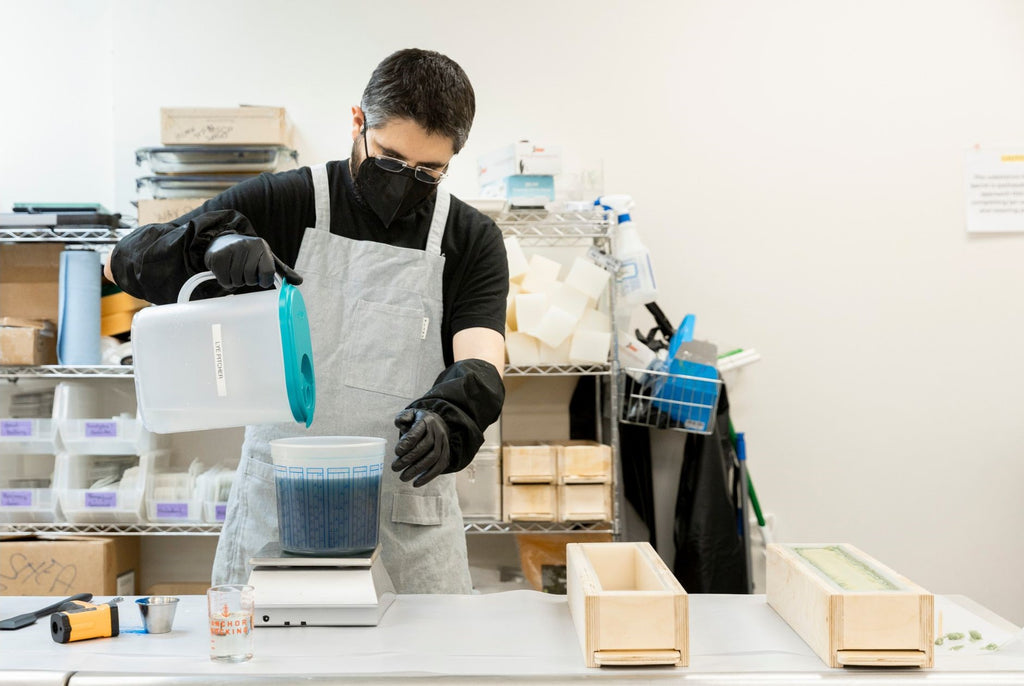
xmin=964 ymin=145 xmax=1024 ymax=233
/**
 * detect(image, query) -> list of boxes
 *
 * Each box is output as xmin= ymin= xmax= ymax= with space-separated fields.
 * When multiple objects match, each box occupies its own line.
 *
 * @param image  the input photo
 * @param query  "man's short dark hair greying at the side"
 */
xmin=359 ymin=48 xmax=476 ymax=153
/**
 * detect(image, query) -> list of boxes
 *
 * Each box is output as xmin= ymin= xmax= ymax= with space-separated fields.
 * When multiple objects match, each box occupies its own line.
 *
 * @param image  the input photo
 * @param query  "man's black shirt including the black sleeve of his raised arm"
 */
xmin=111 ymin=160 xmax=508 ymax=366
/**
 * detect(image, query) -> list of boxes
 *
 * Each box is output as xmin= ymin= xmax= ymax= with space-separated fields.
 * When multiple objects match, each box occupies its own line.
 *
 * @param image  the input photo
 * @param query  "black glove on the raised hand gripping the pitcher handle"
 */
xmin=203 ymin=233 xmax=302 ymax=289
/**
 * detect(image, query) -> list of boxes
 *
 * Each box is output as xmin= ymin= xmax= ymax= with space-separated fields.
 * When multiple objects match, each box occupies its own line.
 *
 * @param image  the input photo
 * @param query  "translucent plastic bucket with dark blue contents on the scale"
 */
xmin=270 ymin=436 xmax=385 ymax=557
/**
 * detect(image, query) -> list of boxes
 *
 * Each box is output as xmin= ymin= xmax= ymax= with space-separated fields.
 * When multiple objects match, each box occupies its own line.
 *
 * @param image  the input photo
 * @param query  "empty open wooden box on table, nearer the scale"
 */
xmin=565 ymin=542 xmax=689 ymax=667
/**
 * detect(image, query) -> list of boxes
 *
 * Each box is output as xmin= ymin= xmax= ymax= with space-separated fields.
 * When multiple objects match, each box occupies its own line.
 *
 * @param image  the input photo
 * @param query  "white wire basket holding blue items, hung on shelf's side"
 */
xmin=618 ymin=366 xmax=722 ymax=434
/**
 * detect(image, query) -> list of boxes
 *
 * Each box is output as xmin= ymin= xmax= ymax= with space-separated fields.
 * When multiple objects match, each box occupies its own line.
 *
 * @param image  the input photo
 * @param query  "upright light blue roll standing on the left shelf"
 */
xmin=57 ymin=250 xmax=102 ymax=365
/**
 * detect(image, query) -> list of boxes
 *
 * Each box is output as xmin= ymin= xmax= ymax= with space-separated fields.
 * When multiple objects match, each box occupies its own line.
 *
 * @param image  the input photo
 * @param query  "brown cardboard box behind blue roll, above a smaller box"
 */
xmin=0 ymin=243 xmax=63 ymax=321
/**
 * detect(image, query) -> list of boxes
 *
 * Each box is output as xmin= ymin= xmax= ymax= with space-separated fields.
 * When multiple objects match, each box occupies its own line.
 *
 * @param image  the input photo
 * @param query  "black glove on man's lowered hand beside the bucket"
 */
xmin=391 ymin=410 xmax=452 ymax=487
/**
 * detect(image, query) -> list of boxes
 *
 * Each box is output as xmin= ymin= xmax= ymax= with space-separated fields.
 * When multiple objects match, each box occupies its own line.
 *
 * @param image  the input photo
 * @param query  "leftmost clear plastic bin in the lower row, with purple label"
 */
xmin=0 ymin=455 xmax=60 ymax=522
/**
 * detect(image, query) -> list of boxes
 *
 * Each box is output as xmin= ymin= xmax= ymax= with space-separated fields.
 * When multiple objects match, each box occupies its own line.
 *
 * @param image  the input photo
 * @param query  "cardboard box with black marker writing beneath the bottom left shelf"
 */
xmin=0 ymin=535 xmax=138 ymax=596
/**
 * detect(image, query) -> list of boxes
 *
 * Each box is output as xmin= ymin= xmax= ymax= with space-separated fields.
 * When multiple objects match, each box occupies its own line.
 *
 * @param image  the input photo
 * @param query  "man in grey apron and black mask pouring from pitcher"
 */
xmin=108 ymin=49 xmax=508 ymax=593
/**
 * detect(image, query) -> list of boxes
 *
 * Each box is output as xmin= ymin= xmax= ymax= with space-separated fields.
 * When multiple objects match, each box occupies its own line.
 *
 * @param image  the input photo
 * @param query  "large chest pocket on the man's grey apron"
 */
xmin=344 ymin=300 xmax=423 ymax=399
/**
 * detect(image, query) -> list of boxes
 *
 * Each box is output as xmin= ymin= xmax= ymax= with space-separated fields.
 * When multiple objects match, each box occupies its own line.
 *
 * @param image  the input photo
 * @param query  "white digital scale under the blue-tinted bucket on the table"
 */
xmin=249 ymin=543 xmax=395 ymax=627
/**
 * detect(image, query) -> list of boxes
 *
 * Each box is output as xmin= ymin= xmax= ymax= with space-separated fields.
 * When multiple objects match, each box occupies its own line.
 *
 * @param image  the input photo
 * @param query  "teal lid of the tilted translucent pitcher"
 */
xmin=278 ymin=282 xmax=316 ymax=427
